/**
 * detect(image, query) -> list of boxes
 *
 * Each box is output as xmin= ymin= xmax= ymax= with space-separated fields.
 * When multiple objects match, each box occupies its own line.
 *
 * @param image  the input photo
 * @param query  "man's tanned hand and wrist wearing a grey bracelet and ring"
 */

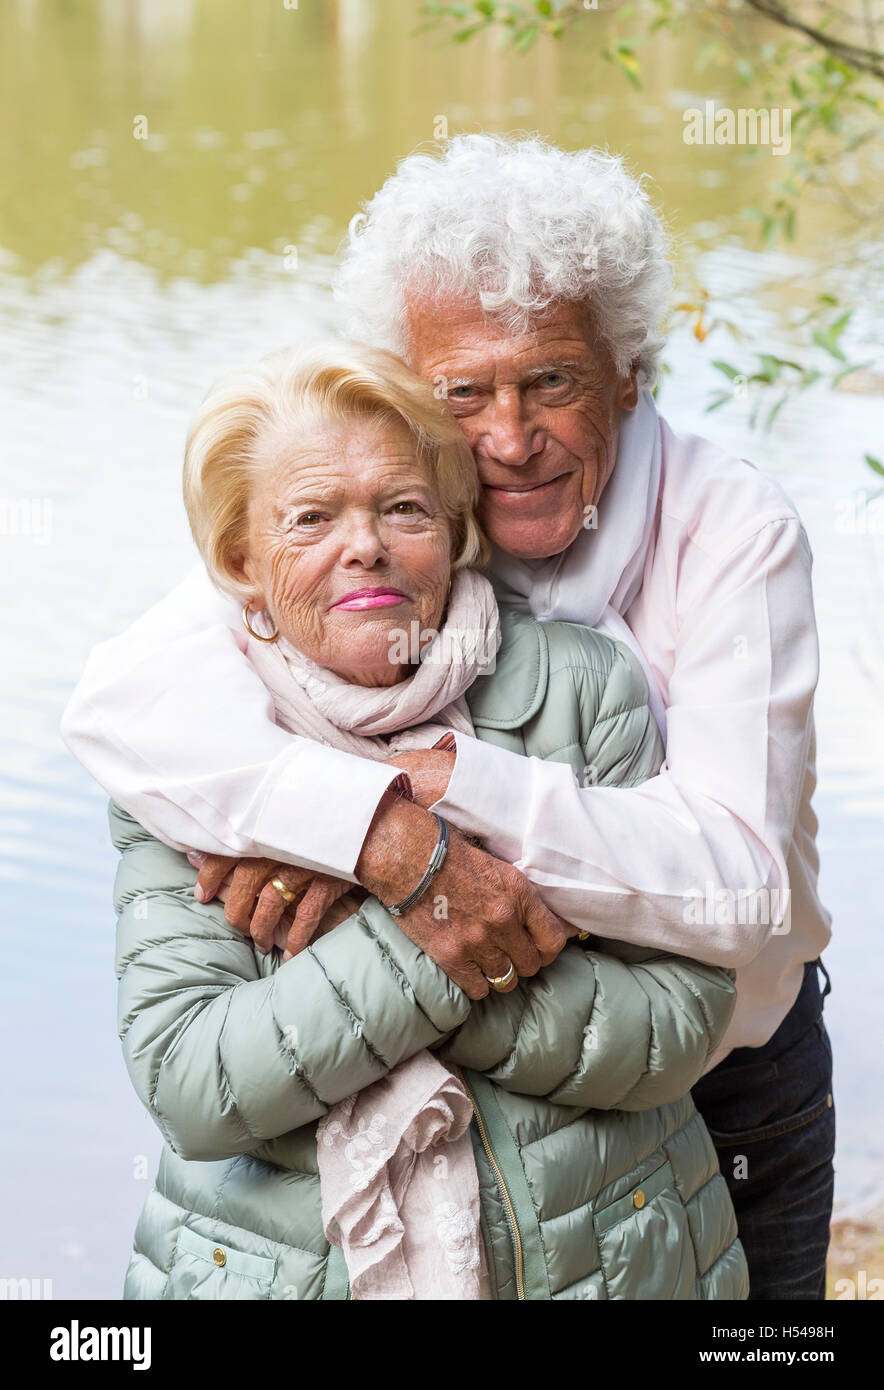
xmin=354 ymin=789 xmax=573 ymax=999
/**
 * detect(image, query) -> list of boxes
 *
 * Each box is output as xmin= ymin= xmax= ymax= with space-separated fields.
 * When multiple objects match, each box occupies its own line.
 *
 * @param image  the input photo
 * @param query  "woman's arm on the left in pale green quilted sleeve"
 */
xmin=110 ymin=806 xmax=470 ymax=1159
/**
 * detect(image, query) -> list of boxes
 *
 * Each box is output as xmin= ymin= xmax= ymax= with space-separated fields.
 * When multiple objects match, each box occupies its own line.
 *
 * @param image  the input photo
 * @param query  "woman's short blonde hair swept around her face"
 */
xmin=183 ymin=343 xmax=489 ymax=598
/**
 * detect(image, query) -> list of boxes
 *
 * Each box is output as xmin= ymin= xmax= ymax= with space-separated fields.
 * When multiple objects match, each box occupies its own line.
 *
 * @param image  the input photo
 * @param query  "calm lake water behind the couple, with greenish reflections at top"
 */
xmin=0 ymin=0 xmax=884 ymax=1297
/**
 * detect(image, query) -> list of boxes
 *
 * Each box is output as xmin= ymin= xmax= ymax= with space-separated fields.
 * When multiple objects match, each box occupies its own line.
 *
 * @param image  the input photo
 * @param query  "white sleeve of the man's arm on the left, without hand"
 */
xmin=61 ymin=566 xmax=403 ymax=881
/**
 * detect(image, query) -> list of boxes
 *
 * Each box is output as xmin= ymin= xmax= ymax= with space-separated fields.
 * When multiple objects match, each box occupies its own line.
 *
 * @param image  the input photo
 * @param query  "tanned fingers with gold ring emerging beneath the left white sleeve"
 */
xmin=188 ymin=852 xmax=353 ymax=956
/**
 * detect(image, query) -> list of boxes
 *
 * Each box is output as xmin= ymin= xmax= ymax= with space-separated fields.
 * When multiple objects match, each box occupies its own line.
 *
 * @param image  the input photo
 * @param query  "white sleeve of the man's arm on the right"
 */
xmin=425 ymin=520 xmax=819 ymax=967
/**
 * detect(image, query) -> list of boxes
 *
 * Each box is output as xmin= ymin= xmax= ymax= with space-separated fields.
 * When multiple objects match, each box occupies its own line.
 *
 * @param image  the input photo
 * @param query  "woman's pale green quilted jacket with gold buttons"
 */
xmin=110 ymin=614 xmax=748 ymax=1300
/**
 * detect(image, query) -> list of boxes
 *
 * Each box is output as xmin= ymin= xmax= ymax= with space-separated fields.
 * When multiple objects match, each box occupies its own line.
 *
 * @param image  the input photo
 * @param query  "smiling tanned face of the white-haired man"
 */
xmin=407 ymin=296 xmax=638 ymax=560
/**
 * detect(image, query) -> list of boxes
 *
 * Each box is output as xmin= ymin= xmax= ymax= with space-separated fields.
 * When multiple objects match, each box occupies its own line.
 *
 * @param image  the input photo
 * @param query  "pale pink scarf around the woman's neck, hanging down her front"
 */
xmin=247 ymin=570 xmax=500 ymax=1301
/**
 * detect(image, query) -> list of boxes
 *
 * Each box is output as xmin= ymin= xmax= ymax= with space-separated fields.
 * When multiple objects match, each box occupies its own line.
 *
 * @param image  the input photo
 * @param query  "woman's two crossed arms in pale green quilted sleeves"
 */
xmin=111 ymin=808 xmax=734 ymax=1159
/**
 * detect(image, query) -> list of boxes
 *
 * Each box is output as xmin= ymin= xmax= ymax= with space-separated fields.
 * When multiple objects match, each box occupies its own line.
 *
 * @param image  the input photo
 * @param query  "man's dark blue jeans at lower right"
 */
xmin=691 ymin=960 xmax=835 ymax=1300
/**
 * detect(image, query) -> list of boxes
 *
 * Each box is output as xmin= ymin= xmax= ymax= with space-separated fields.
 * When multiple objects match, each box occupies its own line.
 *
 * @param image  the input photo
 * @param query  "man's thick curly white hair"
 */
xmin=335 ymin=135 xmax=671 ymax=386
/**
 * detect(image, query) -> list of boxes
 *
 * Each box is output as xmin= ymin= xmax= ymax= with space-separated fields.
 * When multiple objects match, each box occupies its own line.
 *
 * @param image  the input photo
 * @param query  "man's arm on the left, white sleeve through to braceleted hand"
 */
xmin=63 ymin=570 xmax=566 ymax=998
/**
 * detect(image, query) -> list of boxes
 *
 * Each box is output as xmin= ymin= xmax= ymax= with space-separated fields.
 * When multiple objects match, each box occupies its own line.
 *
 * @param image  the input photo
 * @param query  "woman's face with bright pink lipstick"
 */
xmin=234 ymin=420 xmax=452 ymax=685
